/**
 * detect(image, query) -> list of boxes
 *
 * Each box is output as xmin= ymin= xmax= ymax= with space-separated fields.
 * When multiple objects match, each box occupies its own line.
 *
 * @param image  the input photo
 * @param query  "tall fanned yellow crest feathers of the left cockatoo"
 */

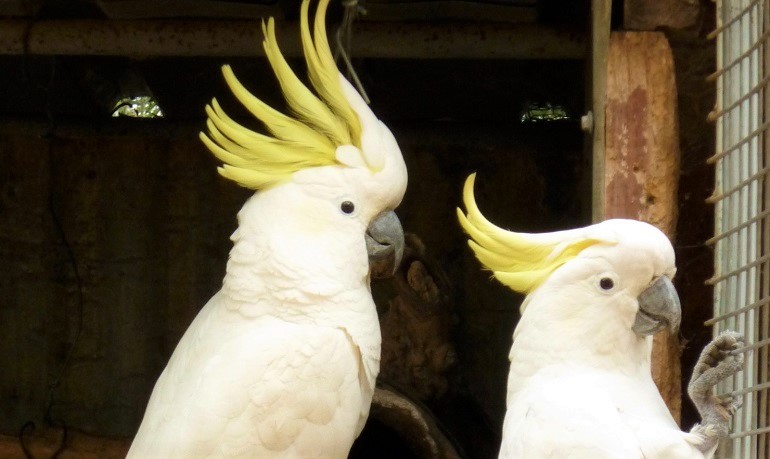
xmin=200 ymin=0 xmax=361 ymax=190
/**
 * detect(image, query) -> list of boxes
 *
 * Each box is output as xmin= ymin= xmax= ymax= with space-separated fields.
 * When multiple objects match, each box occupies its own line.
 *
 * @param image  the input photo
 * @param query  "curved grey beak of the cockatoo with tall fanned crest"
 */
xmin=366 ymin=211 xmax=404 ymax=279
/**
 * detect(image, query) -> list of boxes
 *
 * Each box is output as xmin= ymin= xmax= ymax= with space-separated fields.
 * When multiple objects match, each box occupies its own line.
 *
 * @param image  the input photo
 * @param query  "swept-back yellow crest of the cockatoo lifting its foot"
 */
xmin=457 ymin=173 xmax=602 ymax=293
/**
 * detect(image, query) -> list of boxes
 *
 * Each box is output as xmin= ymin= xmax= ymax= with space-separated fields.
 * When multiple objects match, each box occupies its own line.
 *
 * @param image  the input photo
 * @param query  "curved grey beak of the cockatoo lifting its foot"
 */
xmin=631 ymin=276 xmax=682 ymax=336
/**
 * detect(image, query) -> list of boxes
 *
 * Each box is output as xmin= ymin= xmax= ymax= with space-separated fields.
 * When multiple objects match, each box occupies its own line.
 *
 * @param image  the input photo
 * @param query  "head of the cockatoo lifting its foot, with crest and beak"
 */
xmin=458 ymin=174 xmax=681 ymax=336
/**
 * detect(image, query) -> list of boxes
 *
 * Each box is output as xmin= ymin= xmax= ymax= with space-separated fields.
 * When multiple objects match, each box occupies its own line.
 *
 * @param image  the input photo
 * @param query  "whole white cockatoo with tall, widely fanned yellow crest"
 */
xmin=128 ymin=0 xmax=407 ymax=459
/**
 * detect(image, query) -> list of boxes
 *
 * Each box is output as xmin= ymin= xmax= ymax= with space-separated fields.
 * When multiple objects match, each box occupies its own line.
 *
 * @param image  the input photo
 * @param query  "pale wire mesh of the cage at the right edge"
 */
xmin=707 ymin=0 xmax=770 ymax=459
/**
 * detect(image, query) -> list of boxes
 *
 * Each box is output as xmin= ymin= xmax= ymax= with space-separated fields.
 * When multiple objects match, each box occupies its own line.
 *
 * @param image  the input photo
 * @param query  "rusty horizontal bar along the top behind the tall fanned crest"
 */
xmin=0 ymin=19 xmax=587 ymax=59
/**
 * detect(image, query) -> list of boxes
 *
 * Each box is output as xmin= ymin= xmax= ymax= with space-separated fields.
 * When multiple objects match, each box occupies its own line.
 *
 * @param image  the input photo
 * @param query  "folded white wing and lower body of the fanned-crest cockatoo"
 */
xmin=131 ymin=296 xmax=372 ymax=458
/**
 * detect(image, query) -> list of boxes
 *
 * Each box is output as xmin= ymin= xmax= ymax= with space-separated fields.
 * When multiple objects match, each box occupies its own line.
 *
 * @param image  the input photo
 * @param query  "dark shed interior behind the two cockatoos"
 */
xmin=0 ymin=0 xmax=713 ymax=458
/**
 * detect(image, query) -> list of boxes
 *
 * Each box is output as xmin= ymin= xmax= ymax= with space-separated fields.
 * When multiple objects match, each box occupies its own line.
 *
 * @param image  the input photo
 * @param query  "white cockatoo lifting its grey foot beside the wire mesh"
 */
xmin=458 ymin=174 xmax=743 ymax=459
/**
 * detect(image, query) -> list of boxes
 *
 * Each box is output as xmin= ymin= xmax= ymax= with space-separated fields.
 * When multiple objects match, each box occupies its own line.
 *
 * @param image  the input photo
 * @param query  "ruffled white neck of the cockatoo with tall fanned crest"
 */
xmin=222 ymin=187 xmax=369 ymax=315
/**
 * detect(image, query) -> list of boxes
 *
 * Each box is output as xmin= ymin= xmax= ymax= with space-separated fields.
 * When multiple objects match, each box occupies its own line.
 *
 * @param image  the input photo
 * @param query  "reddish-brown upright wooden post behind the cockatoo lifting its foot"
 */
xmin=604 ymin=32 xmax=682 ymax=422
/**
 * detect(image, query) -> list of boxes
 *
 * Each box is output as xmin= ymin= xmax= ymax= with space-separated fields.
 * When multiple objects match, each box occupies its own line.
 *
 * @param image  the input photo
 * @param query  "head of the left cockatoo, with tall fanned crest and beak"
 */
xmin=200 ymin=0 xmax=407 ymax=274
